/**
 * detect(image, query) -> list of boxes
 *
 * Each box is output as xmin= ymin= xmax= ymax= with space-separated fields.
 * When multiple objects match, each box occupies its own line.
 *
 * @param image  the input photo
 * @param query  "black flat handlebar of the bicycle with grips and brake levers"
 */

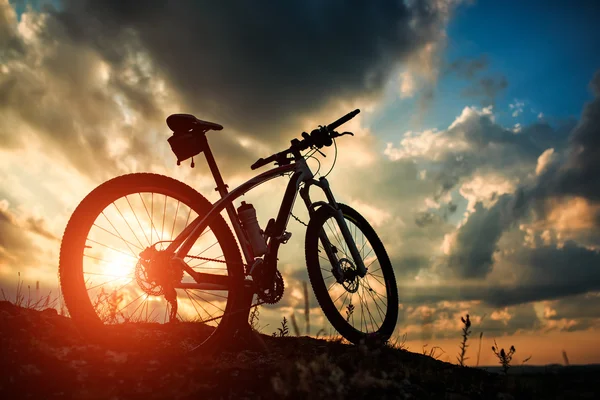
xmin=250 ymin=108 xmax=360 ymax=170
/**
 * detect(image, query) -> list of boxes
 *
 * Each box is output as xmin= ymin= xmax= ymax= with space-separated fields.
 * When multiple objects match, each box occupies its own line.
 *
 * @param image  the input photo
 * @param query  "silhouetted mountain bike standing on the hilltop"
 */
xmin=59 ymin=109 xmax=398 ymax=351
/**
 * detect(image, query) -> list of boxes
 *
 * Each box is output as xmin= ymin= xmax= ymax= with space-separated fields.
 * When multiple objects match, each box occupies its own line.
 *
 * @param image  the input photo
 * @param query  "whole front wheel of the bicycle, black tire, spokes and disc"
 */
xmin=305 ymin=204 xmax=398 ymax=344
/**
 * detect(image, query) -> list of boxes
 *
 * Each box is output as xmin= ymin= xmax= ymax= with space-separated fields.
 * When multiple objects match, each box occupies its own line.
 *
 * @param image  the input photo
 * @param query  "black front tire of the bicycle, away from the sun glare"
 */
xmin=305 ymin=203 xmax=398 ymax=344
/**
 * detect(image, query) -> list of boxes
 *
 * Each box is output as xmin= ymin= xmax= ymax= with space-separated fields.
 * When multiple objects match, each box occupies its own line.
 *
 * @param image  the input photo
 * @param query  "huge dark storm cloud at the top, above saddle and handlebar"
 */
xmin=60 ymin=0 xmax=446 ymax=143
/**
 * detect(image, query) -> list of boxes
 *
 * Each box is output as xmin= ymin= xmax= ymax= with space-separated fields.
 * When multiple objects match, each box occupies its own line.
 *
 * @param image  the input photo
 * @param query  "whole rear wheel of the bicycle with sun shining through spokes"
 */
xmin=59 ymin=173 xmax=244 ymax=352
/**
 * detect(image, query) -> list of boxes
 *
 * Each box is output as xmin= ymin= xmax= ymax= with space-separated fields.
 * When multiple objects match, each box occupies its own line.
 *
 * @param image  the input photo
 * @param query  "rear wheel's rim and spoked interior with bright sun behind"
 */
xmin=82 ymin=189 xmax=234 ymax=328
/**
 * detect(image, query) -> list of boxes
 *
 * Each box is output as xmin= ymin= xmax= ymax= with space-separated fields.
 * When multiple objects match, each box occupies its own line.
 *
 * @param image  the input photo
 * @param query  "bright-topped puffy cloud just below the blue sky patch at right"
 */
xmin=384 ymin=103 xmax=569 ymax=196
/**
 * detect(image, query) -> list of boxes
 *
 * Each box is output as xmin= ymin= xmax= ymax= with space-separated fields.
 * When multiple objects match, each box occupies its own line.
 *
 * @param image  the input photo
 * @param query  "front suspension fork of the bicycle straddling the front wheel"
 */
xmin=300 ymin=177 xmax=367 ymax=282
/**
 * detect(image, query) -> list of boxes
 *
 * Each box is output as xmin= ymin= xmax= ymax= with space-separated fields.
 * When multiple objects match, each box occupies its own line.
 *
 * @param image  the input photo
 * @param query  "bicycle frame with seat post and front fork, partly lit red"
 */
xmin=166 ymin=137 xmax=366 ymax=290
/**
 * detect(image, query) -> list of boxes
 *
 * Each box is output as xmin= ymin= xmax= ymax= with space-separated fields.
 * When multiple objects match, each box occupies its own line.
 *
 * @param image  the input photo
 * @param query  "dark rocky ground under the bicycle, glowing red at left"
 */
xmin=0 ymin=302 xmax=600 ymax=400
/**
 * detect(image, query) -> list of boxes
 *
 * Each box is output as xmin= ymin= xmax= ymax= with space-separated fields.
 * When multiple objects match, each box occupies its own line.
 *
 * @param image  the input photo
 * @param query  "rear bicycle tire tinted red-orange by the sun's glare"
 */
xmin=58 ymin=173 xmax=244 ymax=354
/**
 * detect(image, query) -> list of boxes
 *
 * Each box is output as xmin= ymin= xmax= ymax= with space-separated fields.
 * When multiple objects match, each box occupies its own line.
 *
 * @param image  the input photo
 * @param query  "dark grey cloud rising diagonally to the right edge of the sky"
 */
xmin=451 ymin=69 xmax=600 ymax=277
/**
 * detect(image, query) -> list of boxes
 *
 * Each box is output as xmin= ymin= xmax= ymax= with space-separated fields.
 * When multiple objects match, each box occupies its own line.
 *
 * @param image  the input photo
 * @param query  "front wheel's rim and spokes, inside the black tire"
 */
xmin=318 ymin=215 xmax=388 ymax=334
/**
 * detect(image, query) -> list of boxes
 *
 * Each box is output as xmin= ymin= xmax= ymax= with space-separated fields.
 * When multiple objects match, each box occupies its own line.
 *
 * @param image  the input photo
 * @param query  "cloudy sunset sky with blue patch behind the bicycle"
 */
xmin=0 ymin=0 xmax=600 ymax=365
